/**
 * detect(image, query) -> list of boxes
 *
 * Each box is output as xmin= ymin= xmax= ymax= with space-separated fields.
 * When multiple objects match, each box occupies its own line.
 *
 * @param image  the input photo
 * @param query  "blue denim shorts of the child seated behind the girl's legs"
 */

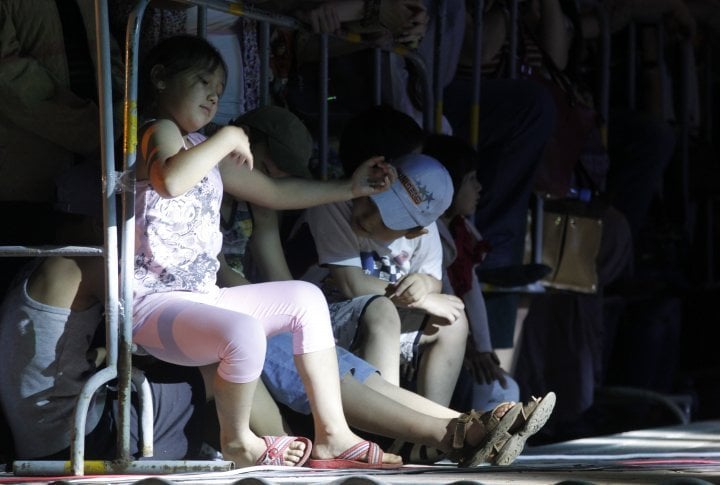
xmin=262 ymin=333 xmax=378 ymax=414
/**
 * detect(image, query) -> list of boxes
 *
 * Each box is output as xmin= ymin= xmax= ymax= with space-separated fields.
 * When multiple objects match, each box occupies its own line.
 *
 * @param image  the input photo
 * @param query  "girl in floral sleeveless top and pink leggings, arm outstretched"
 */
xmin=133 ymin=36 xmax=402 ymax=468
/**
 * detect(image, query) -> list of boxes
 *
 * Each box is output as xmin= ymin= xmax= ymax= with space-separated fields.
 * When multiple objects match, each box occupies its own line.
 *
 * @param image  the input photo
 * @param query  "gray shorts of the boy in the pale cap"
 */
xmin=329 ymin=295 xmax=428 ymax=363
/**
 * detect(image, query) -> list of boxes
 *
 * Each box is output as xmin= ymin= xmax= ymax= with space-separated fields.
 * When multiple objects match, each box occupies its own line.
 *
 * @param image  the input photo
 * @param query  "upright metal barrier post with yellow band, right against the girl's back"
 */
xmin=117 ymin=0 xmax=150 ymax=466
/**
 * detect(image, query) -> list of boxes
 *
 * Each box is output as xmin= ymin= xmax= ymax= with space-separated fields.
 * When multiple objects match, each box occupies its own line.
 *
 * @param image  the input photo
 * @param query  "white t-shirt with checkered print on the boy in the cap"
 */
xmin=303 ymin=201 xmax=442 ymax=302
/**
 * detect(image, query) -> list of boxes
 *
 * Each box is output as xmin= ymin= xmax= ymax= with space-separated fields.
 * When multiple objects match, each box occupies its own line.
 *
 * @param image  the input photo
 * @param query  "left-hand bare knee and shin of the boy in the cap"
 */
xmin=356 ymin=297 xmax=400 ymax=385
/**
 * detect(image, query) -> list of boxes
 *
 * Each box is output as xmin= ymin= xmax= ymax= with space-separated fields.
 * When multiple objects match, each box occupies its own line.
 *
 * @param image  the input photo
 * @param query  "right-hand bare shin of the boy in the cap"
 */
xmin=417 ymin=315 xmax=468 ymax=406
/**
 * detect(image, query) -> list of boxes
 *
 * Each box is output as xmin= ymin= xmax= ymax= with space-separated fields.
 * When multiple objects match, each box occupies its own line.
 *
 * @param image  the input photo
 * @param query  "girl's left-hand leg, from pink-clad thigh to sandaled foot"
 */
xmin=133 ymin=293 xmax=305 ymax=466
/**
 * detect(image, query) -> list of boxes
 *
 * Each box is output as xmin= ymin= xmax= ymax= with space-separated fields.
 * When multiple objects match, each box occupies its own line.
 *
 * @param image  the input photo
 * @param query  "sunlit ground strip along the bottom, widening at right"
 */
xmin=0 ymin=421 xmax=720 ymax=485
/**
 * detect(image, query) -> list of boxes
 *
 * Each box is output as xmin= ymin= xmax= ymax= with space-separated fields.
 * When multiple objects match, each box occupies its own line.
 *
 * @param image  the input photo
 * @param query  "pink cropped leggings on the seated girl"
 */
xmin=133 ymin=281 xmax=335 ymax=383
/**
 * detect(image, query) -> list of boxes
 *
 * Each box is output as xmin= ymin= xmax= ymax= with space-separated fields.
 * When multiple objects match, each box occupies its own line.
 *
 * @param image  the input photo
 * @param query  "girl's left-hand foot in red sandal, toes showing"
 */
xmin=222 ymin=436 xmax=307 ymax=468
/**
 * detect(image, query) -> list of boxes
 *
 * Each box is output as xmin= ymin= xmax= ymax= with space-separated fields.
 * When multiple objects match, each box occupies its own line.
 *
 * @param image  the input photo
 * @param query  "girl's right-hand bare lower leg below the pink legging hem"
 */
xmin=295 ymin=347 xmax=402 ymax=463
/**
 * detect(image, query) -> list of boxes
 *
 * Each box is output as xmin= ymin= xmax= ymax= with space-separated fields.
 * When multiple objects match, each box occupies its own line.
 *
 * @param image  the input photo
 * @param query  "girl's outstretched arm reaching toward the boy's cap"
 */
xmin=218 ymin=154 xmax=395 ymax=210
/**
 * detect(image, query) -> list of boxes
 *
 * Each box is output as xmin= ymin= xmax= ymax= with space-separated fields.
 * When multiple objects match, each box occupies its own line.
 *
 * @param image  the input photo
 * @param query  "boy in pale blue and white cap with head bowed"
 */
xmin=306 ymin=154 xmax=468 ymax=405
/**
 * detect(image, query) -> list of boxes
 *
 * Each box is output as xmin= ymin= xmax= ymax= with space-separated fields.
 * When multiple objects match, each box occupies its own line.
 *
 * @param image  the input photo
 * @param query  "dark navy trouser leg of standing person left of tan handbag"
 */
xmin=445 ymin=78 xmax=555 ymax=269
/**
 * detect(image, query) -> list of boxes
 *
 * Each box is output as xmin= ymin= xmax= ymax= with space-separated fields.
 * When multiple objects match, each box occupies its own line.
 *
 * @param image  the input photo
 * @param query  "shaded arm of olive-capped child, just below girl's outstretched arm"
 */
xmin=249 ymin=205 xmax=293 ymax=281
